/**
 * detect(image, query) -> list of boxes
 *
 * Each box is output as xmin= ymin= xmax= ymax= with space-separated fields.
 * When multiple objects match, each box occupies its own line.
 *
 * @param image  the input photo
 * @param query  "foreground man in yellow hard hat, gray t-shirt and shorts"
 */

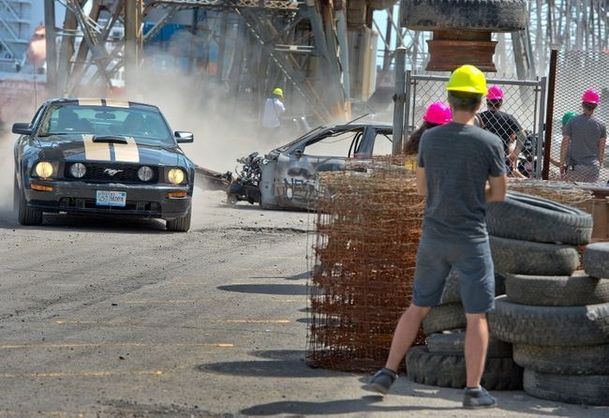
xmin=367 ymin=65 xmax=506 ymax=408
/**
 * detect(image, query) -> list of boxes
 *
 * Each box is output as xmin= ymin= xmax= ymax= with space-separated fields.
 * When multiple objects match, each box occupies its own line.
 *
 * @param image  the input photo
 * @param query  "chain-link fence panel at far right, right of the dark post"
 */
xmin=548 ymin=51 xmax=609 ymax=184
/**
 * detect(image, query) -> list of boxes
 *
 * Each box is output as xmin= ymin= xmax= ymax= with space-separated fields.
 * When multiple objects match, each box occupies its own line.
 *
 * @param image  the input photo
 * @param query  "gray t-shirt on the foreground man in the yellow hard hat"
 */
xmin=418 ymin=123 xmax=505 ymax=242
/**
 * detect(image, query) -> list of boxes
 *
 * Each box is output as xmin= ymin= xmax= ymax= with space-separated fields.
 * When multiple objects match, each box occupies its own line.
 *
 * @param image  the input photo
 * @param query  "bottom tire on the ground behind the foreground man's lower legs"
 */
xmin=406 ymin=346 xmax=522 ymax=390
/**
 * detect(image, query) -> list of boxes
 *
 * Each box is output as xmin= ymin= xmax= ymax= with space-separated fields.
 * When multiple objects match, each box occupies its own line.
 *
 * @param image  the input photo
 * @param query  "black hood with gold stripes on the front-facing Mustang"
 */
xmin=33 ymin=134 xmax=185 ymax=166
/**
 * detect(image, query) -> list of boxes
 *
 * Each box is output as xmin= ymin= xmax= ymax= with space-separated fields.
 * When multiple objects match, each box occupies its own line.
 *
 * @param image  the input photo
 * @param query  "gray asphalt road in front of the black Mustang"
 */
xmin=0 ymin=190 xmax=609 ymax=417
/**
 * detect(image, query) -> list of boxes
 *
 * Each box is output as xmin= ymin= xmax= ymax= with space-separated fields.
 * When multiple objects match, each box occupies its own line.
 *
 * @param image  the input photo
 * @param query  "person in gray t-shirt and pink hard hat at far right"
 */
xmin=560 ymin=90 xmax=607 ymax=183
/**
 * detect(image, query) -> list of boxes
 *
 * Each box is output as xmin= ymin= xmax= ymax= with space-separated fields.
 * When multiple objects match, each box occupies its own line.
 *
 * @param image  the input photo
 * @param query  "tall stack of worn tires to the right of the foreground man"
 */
xmin=487 ymin=194 xmax=609 ymax=405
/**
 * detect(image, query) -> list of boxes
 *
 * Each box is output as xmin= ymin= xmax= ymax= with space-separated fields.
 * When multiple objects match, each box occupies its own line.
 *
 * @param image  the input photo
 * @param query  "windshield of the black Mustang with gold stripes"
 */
xmin=38 ymin=103 xmax=175 ymax=146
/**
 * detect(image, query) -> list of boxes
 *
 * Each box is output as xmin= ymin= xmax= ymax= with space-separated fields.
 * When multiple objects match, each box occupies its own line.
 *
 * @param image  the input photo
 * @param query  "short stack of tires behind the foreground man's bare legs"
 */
xmin=406 ymin=272 xmax=522 ymax=390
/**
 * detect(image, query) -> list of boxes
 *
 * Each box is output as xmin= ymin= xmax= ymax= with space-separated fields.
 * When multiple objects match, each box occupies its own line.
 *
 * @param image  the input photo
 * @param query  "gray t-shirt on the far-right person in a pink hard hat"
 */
xmin=563 ymin=114 xmax=607 ymax=165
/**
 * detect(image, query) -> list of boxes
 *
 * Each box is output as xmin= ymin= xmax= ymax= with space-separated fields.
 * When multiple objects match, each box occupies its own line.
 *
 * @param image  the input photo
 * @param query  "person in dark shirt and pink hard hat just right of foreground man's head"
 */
xmin=479 ymin=86 xmax=526 ymax=177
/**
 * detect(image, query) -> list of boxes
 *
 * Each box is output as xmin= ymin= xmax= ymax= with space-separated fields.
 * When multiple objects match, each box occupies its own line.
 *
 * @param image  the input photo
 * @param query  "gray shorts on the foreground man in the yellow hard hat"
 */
xmin=412 ymin=235 xmax=495 ymax=313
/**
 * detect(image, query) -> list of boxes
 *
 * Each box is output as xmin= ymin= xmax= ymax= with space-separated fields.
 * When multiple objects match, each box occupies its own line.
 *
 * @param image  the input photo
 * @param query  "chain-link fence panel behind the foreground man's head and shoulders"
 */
xmin=404 ymin=72 xmax=546 ymax=178
